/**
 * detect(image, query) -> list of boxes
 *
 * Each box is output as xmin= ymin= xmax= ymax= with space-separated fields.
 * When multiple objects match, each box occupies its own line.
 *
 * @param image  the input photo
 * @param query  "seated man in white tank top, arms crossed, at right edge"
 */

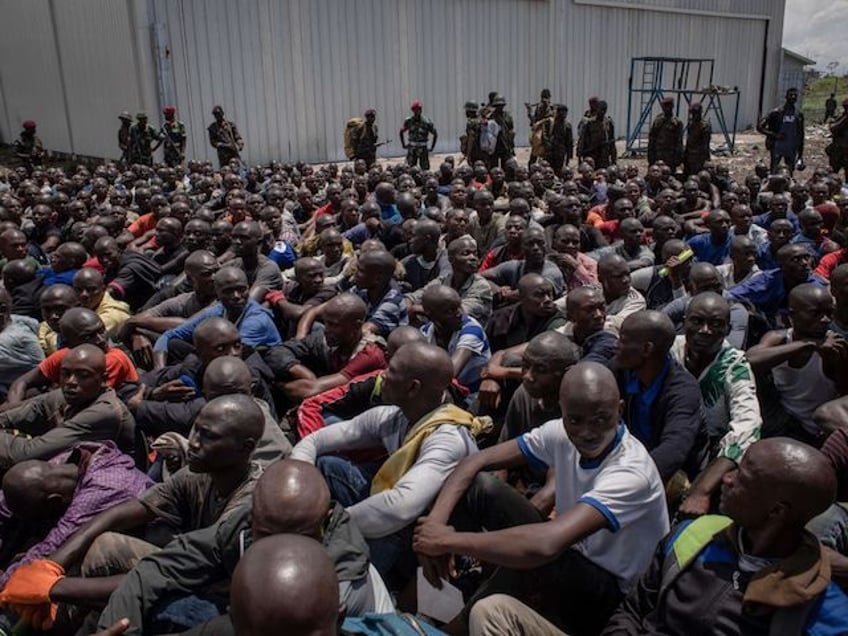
xmin=747 ymin=284 xmax=848 ymax=446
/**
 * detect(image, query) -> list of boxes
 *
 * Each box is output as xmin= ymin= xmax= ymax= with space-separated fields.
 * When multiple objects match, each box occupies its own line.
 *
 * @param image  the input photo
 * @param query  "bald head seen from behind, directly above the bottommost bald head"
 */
xmin=251 ymin=459 xmax=330 ymax=539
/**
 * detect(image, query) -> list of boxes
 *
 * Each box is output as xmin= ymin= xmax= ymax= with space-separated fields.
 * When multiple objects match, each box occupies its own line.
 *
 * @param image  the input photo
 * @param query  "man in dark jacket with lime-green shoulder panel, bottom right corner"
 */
xmin=604 ymin=438 xmax=848 ymax=636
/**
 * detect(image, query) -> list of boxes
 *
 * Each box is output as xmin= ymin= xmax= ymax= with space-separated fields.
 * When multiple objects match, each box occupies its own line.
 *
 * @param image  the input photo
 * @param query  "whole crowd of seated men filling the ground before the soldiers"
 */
xmin=0 ymin=145 xmax=848 ymax=636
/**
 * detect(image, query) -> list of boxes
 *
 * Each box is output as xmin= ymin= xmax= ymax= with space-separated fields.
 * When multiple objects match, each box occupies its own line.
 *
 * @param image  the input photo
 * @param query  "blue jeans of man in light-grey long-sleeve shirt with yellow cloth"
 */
xmin=317 ymin=455 xmax=418 ymax=591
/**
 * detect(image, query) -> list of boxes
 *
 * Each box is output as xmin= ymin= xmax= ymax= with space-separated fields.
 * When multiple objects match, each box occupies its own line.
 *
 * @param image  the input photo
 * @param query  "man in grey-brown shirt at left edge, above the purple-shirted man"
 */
xmin=0 ymin=344 xmax=135 ymax=468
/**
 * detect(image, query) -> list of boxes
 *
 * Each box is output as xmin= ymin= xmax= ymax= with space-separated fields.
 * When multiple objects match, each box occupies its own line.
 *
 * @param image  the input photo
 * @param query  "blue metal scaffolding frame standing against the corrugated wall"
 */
xmin=626 ymin=57 xmax=739 ymax=156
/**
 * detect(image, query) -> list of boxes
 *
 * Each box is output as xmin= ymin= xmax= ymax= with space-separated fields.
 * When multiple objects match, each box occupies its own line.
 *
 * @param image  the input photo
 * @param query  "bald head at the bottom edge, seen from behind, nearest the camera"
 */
xmin=230 ymin=534 xmax=339 ymax=636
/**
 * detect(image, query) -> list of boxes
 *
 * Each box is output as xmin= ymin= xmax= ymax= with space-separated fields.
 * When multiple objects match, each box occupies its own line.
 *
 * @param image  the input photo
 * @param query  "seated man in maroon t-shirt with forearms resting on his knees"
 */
xmin=264 ymin=294 xmax=386 ymax=401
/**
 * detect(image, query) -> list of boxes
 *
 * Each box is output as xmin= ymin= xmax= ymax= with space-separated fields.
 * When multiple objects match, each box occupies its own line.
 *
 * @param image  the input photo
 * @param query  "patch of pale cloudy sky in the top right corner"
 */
xmin=783 ymin=0 xmax=848 ymax=75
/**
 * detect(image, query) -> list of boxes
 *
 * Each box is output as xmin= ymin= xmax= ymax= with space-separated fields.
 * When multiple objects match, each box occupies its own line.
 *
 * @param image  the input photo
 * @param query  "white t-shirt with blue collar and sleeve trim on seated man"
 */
xmin=517 ymin=418 xmax=669 ymax=593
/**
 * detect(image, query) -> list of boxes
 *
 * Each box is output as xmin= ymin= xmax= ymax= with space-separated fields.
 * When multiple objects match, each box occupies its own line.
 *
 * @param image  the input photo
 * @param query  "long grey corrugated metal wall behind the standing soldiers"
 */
xmin=0 ymin=0 xmax=784 ymax=162
